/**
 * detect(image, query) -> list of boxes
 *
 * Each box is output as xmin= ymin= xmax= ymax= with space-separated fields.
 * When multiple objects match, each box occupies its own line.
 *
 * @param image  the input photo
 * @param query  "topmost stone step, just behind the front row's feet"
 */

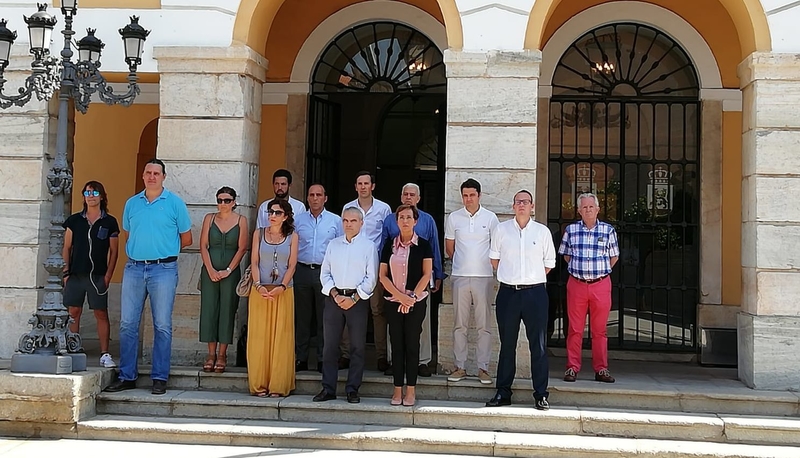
xmin=131 ymin=367 xmax=800 ymax=416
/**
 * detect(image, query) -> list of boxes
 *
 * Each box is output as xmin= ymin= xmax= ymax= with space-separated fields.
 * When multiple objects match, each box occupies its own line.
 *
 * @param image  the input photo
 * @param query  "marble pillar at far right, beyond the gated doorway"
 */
xmin=738 ymin=53 xmax=800 ymax=390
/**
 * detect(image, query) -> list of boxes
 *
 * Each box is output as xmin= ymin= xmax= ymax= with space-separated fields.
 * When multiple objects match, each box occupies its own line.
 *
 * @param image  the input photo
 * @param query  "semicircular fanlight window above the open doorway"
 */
xmin=312 ymin=22 xmax=446 ymax=93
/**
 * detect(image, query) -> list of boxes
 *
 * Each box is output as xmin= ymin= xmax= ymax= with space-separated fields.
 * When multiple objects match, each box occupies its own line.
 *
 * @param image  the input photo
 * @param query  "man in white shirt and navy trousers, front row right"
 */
xmin=486 ymin=189 xmax=556 ymax=410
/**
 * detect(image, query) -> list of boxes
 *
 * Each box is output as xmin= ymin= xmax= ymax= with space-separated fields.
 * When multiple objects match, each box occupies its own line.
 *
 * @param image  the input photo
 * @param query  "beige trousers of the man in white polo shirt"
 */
xmin=451 ymin=276 xmax=494 ymax=371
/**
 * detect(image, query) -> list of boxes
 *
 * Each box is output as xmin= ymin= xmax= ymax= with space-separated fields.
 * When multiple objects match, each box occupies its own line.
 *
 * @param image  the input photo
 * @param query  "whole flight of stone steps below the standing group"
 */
xmin=77 ymin=368 xmax=800 ymax=458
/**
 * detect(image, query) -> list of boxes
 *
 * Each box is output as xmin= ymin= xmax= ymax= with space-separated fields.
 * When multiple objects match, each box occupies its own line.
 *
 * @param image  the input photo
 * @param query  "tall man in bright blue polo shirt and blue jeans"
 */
xmin=106 ymin=159 xmax=192 ymax=395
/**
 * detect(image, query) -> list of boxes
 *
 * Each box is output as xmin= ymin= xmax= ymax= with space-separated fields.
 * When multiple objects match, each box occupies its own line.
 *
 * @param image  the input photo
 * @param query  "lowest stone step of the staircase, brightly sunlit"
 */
xmin=76 ymin=415 xmax=800 ymax=458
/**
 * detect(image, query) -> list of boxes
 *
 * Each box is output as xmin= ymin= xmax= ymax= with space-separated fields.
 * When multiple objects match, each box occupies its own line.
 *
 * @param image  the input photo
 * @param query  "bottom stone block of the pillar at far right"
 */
xmin=738 ymin=313 xmax=800 ymax=391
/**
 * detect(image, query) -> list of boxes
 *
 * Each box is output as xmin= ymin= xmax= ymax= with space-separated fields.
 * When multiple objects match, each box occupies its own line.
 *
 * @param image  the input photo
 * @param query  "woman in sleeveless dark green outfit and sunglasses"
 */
xmin=200 ymin=186 xmax=249 ymax=372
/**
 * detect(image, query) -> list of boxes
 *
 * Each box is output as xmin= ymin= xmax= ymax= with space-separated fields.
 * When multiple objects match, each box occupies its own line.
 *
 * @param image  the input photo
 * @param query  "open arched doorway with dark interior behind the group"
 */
xmin=306 ymin=22 xmax=446 ymax=213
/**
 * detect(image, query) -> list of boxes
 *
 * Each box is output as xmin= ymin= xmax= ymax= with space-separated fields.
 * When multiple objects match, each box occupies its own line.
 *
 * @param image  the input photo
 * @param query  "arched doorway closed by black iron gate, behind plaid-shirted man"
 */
xmin=547 ymin=23 xmax=701 ymax=351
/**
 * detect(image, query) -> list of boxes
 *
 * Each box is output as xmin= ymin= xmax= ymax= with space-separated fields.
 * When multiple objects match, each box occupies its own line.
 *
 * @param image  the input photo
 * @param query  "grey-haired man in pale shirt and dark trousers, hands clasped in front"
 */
xmin=313 ymin=207 xmax=378 ymax=404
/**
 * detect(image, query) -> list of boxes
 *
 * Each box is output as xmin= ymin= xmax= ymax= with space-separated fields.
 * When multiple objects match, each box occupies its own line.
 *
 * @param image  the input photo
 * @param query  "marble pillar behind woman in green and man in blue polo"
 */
xmin=152 ymin=46 xmax=267 ymax=366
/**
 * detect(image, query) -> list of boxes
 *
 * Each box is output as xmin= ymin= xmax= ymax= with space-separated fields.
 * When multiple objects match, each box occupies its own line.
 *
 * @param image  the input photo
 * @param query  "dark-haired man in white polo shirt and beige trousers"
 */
xmin=444 ymin=178 xmax=499 ymax=385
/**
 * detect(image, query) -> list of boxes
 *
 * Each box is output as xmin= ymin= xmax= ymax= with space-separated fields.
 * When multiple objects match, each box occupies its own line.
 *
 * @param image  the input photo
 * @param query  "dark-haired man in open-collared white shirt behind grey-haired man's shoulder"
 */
xmin=339 ymin=171 xmax=393 ymax=372
